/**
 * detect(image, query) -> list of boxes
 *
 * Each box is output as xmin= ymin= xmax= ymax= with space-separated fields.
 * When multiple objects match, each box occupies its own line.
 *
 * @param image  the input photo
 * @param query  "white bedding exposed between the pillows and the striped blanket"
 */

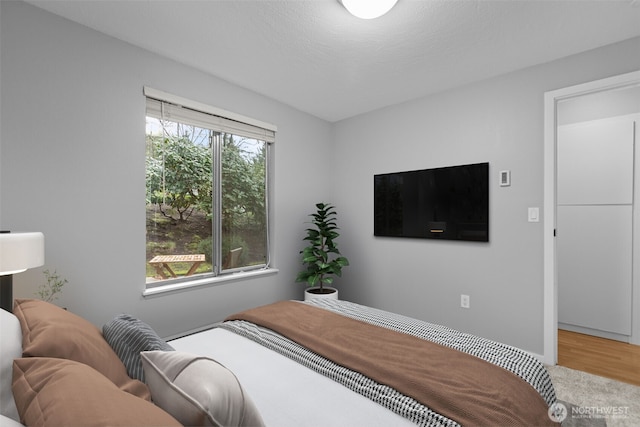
xmin=170 ymin=328 xmax=415 ymax=427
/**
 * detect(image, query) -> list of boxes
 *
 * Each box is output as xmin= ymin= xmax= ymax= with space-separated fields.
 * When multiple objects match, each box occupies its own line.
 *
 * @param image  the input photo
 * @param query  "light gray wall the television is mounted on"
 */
xmin=334 ymin=38 xmax=640 ymax=354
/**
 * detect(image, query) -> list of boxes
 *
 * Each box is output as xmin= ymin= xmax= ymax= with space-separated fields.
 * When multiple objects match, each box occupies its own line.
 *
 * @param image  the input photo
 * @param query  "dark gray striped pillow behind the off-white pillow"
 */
xmin=102 ymin=314 xmax=174 ymax=382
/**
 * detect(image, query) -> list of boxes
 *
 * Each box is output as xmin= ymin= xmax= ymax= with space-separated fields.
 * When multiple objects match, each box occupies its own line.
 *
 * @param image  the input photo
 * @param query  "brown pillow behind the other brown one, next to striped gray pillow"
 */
xmin=13 ymin=299 xmax=151 ymax=400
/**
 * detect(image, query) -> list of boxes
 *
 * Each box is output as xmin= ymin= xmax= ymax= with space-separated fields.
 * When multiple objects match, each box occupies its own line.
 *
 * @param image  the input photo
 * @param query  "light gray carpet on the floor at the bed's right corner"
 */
xmin=547 ymin=366 xmax=640 ymax=427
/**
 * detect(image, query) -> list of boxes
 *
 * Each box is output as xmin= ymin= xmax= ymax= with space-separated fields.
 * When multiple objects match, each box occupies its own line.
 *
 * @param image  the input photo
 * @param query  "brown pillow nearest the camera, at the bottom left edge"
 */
xmin=12 ymin=357 xmax=181 ymax=427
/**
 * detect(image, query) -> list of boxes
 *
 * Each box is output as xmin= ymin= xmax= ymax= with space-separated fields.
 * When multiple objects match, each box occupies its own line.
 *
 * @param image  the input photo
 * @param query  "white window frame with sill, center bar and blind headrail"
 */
xmin=143 ymin=86 xmax=277 ymax=297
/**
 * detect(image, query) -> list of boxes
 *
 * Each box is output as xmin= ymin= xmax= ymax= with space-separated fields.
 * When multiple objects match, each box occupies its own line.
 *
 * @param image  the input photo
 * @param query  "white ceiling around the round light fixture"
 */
xmin=27 ymin=0 xmax=640 ymax=122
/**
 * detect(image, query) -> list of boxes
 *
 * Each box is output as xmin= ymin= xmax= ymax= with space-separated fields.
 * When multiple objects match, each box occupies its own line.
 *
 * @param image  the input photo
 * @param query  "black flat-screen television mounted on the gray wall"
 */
xmin=373 ymin=163 xmax=489 ymax=242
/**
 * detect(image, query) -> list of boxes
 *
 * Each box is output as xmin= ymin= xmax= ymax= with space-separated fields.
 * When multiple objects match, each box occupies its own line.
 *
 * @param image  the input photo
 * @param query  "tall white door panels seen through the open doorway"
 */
xmin=557 ymin=117 xmax=634 ymax=337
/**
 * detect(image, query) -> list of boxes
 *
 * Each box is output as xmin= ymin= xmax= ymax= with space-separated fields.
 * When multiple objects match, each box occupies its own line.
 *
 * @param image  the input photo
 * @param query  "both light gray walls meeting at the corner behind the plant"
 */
xmin=0 ymin=2 xmax=640 ymax=354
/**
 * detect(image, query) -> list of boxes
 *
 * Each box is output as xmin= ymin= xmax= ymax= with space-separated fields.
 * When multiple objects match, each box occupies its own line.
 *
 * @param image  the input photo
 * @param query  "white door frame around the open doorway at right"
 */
xmin=543 ymin=71 xmax=640 ymax=366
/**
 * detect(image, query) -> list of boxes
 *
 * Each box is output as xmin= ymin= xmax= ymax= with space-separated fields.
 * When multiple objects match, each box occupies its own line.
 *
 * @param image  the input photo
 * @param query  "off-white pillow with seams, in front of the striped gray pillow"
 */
xmin=140 ymin=351 xmax=264 ymax=427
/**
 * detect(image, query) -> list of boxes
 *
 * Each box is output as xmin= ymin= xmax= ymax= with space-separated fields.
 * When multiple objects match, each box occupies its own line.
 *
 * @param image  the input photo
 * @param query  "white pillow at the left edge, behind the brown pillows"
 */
xmin=0 ymin=309 xmax=22 ymax=421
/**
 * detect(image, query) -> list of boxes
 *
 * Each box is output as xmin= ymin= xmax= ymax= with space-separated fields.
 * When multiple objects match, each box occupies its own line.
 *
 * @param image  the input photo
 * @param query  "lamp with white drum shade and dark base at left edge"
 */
xmin=0 ymin=231 xmax=44 ymax=312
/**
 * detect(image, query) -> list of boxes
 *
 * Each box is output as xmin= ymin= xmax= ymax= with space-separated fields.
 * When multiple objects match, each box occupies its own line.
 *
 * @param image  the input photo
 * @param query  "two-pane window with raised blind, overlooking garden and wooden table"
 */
xmin=145 ymin=87 xmax=275 ymax=288
